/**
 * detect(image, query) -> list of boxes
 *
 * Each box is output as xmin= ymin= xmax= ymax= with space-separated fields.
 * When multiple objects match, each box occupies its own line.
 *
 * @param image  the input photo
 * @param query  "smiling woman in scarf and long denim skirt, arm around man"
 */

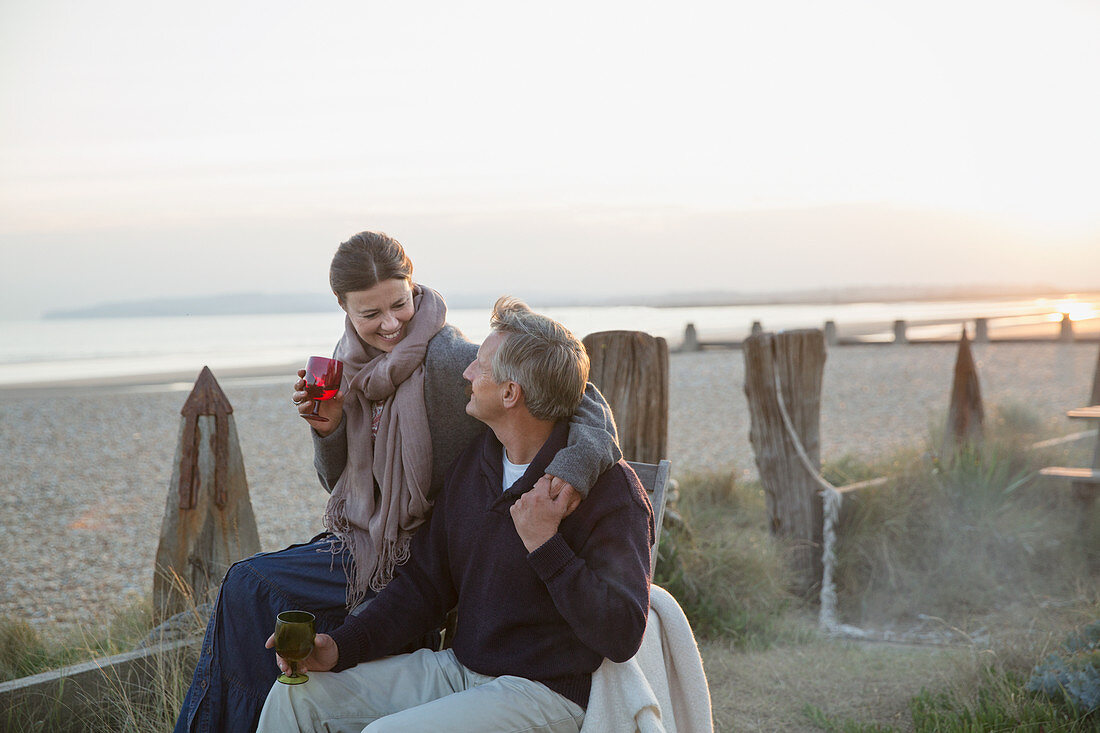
xmin=176 ymin=232 xmax=622 ymax=733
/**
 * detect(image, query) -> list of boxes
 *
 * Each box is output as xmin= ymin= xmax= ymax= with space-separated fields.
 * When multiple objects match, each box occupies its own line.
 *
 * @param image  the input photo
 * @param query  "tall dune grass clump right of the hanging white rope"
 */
xmin=835 ymin=402 xmax=1100 ymax=627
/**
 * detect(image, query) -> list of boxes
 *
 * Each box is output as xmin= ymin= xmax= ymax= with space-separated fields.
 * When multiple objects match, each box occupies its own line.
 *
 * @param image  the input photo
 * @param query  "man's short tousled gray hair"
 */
xmin=490 ymin=295 xmax=589 ymax=420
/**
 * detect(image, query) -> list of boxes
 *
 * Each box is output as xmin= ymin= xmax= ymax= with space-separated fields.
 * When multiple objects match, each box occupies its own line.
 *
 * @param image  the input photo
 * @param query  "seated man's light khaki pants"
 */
xmin=260 ymin=649 xmax=584 ymax=733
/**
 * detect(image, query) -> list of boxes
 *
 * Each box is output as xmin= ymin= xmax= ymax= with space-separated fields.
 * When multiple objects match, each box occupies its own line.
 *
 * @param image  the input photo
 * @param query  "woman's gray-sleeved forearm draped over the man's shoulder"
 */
xmin=547 ymin=382 xmax=623 ymax=497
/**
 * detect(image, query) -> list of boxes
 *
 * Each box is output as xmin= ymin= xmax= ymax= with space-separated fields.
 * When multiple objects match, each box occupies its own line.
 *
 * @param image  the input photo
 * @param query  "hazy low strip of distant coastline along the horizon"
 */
xmin=34 ymin=285 xmax=1100 ymax=320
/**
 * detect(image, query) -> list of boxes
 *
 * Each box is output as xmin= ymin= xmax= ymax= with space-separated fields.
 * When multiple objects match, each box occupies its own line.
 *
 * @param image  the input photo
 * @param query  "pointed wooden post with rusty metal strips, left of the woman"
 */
xmin=153 ymin=367 xmax=260 ymax=623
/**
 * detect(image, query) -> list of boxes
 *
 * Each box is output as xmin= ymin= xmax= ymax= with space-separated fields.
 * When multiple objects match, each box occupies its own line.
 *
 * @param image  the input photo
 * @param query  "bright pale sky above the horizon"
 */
xmin=0 ymin=0 xmax=1100 ymax=318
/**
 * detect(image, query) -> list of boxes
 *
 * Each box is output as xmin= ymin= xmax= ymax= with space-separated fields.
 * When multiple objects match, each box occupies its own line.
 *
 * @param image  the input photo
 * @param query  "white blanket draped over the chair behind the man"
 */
xmin=581 ymin=586 xmax=714 ymax=733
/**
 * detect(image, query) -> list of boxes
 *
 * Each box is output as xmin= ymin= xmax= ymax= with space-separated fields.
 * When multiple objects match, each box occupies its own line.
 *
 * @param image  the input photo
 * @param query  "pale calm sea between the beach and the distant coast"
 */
xmin=0 ymin=293 xmax=1100 ymax=389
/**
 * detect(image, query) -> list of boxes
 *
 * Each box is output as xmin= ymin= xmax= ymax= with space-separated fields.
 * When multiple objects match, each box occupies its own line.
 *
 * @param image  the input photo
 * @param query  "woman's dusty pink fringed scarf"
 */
xmin=325 ymin=285 xmax=447 ymax=609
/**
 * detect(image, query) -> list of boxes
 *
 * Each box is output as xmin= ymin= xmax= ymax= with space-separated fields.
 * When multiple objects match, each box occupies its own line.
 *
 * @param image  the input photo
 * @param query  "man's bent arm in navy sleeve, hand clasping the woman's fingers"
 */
xmin=512 ymin=469 xmax=652 ymax=661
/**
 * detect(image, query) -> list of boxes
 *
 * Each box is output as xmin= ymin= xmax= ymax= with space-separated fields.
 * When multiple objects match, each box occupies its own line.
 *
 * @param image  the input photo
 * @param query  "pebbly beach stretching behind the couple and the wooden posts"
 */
xmin=0 ymin=343 xmax=1097 ymax=635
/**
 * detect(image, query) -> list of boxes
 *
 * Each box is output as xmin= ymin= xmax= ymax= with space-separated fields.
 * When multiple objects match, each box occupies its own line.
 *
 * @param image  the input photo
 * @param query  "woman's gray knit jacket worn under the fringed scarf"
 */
xmin=312 ymin=325 xmax=623 ymax=499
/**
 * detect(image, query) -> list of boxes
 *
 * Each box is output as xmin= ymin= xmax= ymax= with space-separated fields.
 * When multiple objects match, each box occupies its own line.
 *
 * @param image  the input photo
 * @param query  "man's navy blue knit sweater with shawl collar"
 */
xmin=331 ymin=423 xmax=653 ymax=707
